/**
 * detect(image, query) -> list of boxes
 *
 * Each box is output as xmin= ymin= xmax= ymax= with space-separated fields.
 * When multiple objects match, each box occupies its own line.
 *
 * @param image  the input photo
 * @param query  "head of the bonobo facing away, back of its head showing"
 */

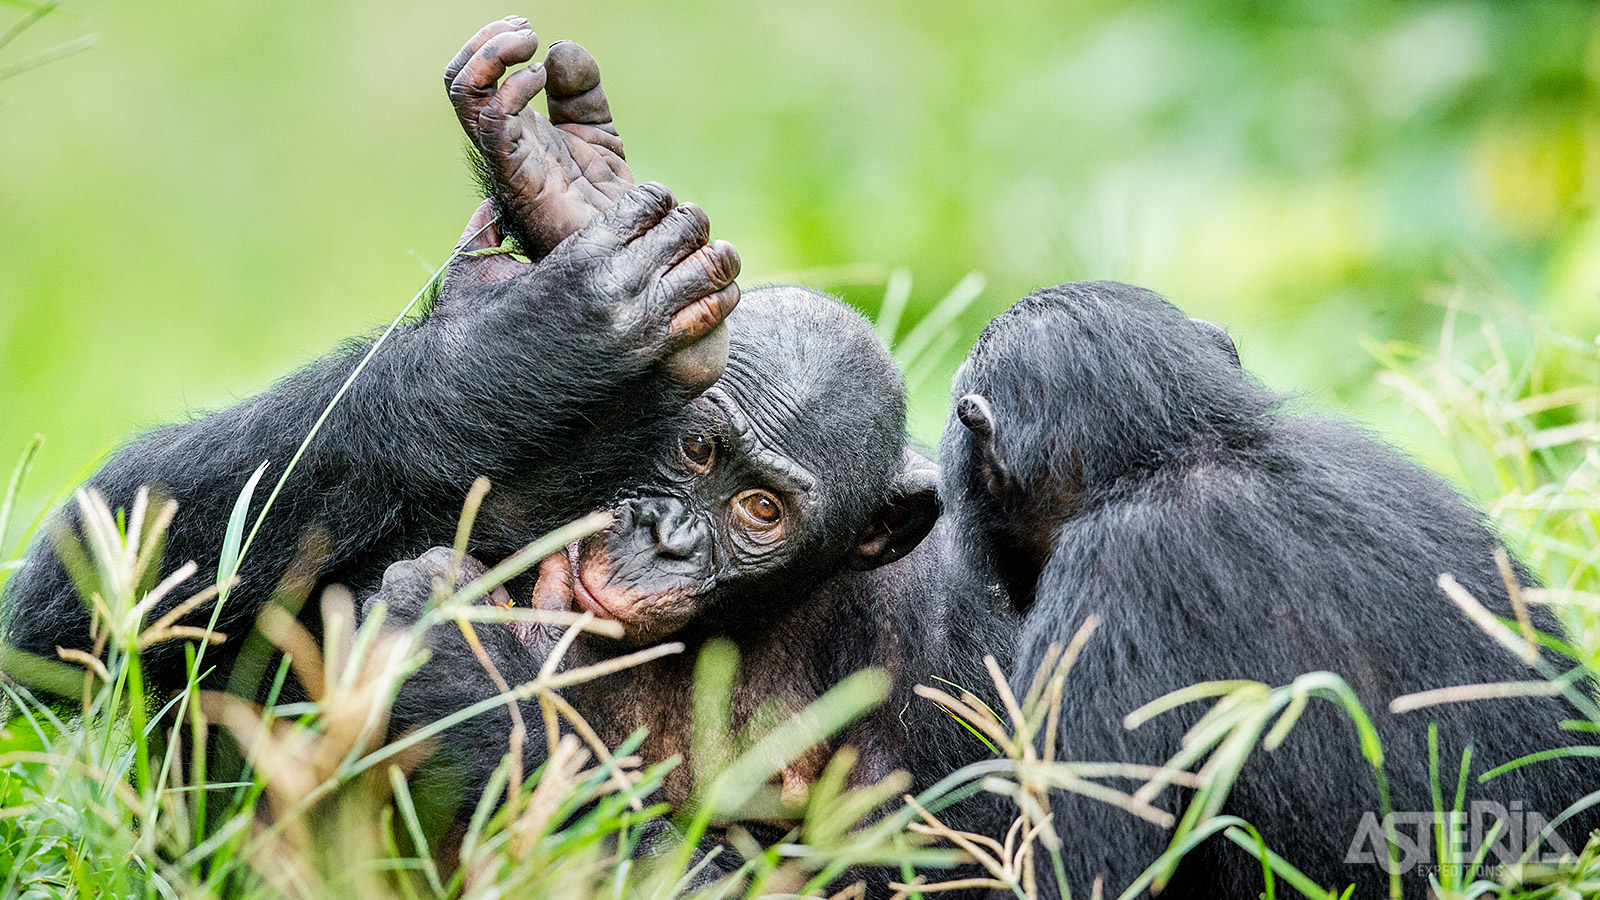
xmin=939 ymin=282 xmax=1277 ymax=605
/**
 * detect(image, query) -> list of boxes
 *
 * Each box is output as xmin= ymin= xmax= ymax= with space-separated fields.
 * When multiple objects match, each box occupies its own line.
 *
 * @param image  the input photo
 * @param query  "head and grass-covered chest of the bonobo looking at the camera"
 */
xmin=368 ymin=287 xmax=972 ymax=813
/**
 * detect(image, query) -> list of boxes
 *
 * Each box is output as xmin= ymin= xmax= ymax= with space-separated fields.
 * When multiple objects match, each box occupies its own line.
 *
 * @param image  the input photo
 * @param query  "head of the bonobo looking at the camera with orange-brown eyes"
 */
xmin=539 ymin=287 xmax=939 ymax=642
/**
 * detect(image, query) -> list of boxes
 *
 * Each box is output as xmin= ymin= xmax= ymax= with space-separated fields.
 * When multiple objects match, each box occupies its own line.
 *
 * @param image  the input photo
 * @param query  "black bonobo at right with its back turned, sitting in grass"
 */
xmin=941 ymin=282 xmax=1595 ymax=897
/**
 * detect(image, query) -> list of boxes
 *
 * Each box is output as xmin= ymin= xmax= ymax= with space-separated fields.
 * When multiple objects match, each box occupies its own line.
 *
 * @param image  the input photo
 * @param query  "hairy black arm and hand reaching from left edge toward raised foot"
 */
xmin=6 ymin=184 xmax=739 ymax=685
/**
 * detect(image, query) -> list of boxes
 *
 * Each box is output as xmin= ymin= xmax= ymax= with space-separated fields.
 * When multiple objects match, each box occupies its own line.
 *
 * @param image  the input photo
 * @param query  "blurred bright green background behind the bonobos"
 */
xmin=0 ymin=0 xmax=1600 ymax=544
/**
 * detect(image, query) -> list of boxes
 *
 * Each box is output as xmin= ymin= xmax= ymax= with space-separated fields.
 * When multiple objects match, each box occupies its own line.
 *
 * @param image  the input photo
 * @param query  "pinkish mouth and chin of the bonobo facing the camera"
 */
xmin=523 ymin=532 xmax=698 ymax=645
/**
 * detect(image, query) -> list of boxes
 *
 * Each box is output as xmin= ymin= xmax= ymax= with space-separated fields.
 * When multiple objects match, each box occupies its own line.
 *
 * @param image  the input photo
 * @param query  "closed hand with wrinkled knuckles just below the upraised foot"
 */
xmin=437 ymin=183 xmax=739 ymax=389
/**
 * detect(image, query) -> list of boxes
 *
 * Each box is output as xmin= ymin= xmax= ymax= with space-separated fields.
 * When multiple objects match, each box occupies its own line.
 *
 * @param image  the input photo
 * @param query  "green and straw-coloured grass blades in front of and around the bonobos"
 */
xmin=0 ymin=256 xmax=1600 ymax=900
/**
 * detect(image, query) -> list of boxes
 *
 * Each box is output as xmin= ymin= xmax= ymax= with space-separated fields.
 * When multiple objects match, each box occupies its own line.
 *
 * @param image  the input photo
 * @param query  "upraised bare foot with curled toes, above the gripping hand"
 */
xmin=445 ymin=16 xmax=634 ymax=259
